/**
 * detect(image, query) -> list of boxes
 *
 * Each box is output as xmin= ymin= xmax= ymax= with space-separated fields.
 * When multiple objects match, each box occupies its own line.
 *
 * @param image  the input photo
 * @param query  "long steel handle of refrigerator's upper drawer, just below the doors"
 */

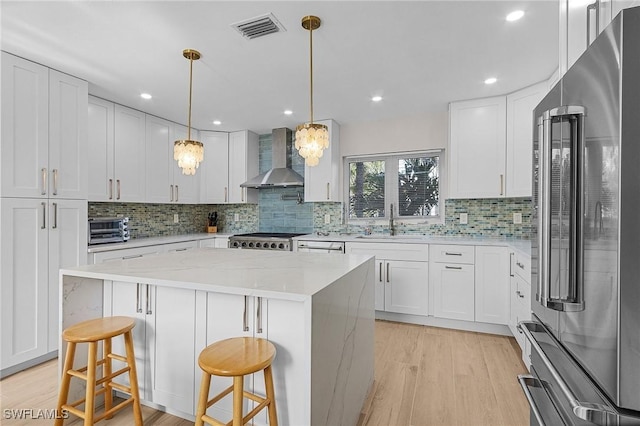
xmin=518 ymin=321 xmax=622 ymax=425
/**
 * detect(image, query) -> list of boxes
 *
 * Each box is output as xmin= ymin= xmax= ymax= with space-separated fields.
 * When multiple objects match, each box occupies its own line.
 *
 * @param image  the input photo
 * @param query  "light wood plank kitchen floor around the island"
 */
xmin=0 ymin=321 xmax=529 ymax=426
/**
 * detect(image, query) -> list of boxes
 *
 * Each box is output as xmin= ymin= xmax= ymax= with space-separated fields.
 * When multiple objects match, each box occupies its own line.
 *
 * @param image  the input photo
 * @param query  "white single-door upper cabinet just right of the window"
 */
xmin=449 ymin=96 xmax=507 ymax=198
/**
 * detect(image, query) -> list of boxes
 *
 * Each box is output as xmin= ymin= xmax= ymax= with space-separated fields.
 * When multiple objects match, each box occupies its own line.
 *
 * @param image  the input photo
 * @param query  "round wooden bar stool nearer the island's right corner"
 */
xmin=195 ymin=337 xmax=278 ymax=426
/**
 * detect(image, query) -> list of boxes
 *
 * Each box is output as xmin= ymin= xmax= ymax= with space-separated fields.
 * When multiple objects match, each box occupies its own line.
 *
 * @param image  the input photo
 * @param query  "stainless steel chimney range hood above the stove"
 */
xmin=240 ymin=127 xmax=304 ymax=188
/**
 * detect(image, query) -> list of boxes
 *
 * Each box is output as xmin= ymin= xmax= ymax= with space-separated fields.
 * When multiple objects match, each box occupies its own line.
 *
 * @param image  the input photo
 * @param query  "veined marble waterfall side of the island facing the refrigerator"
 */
xmin=311 ymin=258 xmax=375 ymax=426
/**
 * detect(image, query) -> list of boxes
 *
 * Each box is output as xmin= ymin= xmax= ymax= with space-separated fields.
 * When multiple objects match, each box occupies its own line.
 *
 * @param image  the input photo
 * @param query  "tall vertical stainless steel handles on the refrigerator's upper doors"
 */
xmin=536 ymin=105 xmax=586 ymax=312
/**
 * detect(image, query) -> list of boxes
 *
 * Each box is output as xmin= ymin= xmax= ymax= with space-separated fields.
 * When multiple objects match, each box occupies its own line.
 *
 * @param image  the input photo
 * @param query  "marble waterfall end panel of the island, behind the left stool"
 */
xmin=58 ymin=275 xmax=103 ymax=405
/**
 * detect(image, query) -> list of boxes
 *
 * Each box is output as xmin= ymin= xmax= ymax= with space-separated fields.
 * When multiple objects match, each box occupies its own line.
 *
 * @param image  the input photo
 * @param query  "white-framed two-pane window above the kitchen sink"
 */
xmin=345 ymin=151 xmax=440 ymax=219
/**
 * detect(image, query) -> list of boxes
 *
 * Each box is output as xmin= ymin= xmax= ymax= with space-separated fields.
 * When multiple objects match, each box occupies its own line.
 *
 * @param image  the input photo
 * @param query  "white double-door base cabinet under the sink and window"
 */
xmin=345 ymin=242 xmax=429 ymax=315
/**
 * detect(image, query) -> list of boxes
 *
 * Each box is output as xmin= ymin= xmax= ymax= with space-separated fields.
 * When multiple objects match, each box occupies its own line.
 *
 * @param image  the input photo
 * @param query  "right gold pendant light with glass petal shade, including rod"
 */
xmin=295 ymin=16 xmax=329 ymax=166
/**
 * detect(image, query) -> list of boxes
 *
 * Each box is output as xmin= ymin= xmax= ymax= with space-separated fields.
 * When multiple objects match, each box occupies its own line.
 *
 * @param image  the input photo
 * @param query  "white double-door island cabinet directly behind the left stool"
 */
xmin=105 ymin=281 xmax=196 ymax=415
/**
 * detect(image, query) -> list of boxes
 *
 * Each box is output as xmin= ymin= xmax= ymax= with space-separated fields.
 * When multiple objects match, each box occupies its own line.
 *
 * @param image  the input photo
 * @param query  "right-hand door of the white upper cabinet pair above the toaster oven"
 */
xmin=113 ymin=104 xmax=146 ymax=202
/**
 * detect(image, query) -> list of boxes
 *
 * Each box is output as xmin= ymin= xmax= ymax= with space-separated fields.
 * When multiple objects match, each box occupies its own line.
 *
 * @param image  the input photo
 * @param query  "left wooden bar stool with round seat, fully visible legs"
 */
xmin=55 ymin=317 xmax=142 ymax=426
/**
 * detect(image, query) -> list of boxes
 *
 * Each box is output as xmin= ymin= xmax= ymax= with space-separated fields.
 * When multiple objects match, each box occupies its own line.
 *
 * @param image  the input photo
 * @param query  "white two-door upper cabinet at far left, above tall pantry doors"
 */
xmin=0 ymin=52 xmax=88 ymax=199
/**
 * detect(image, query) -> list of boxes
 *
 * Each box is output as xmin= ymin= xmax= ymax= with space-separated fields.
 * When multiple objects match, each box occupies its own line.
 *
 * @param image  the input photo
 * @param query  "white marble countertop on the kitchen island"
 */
xmin=60 ymin=248 xmax=371 ymax=301
